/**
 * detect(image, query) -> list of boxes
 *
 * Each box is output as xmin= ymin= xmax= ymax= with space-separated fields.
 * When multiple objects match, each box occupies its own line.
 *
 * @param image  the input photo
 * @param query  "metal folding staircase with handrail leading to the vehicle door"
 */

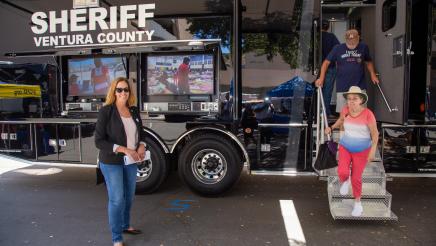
xmin=316 ymin=90 xmax=398 ymax=221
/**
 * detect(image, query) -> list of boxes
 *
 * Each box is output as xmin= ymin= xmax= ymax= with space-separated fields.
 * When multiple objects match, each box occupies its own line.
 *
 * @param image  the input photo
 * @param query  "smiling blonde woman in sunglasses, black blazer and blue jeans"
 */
xmin=95 ymin=77 xmax=145 ymax=246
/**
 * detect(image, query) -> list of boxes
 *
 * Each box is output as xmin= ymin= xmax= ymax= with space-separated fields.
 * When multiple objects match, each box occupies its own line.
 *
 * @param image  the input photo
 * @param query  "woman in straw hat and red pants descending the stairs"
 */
xmin=325 ymin=86 xmax=378 ymax=216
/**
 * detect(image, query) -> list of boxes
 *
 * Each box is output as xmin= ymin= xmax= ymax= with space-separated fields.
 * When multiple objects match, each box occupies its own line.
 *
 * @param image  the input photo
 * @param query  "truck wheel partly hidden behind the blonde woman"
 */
xmin=136 ymin=140 xmax=170 ymax=194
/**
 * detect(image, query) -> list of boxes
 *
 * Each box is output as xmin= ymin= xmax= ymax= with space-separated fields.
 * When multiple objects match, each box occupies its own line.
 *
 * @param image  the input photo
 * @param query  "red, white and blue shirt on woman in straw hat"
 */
xmin=339 ymin=106 xmax=376 ymax=153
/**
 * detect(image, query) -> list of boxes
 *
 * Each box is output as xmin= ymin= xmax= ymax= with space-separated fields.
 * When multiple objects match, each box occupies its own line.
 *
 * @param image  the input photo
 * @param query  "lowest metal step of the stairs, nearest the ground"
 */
xmin=330 ymin=199 xmax=398 ymax=220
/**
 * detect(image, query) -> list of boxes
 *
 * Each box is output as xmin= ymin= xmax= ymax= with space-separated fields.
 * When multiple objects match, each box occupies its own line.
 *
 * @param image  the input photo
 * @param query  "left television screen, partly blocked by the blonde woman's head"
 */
xmin=68 ymin=57 xmax=126 ymax=96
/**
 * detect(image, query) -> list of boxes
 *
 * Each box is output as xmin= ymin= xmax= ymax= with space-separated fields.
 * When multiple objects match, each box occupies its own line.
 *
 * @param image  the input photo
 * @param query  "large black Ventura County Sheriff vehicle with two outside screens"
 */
xmin=0 ymin=0 xmax=436 ymax=219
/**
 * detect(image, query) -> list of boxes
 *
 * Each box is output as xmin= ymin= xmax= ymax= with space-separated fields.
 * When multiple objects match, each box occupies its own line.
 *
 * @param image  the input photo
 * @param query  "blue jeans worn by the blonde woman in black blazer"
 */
xmin=100 ymin=162 xmax=138 ymax=242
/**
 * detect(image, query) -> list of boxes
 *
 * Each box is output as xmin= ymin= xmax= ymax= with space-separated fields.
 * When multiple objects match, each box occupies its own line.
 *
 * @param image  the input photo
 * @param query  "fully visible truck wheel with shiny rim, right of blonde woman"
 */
xmin=178 ymin=135 xmax=243 ymax=196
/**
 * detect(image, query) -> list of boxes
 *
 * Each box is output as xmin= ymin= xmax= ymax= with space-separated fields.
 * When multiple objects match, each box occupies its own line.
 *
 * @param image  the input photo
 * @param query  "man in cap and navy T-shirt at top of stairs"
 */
xmin=315 ymin=29 xmax=379 ymax=112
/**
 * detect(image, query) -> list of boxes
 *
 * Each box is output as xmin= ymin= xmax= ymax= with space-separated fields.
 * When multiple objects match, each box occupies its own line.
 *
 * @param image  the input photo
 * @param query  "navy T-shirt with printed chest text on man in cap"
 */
xmin=326 ymin=42 xmax=372 ymax=92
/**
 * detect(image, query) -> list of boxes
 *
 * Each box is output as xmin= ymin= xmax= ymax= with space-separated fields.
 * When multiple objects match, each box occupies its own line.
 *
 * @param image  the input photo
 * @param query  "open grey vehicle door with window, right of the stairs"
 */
xmin=374 ymin=0 xmax=410 ymax=124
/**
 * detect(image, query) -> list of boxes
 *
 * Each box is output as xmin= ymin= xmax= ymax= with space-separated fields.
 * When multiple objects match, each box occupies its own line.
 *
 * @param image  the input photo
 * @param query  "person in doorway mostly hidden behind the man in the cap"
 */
xmin=321 ymin=20 xmax=339 ymax=117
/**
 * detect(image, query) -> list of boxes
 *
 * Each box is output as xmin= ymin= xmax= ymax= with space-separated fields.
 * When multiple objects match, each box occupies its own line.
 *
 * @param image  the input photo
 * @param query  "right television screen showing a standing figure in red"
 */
xmin=147 ymin=54 xmax=214 ymax=96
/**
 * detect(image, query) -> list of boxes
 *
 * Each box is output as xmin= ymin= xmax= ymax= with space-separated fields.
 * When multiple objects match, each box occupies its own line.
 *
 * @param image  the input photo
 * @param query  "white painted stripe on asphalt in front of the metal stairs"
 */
xmin=280 ymin=200 xmax=306 ymax=246
